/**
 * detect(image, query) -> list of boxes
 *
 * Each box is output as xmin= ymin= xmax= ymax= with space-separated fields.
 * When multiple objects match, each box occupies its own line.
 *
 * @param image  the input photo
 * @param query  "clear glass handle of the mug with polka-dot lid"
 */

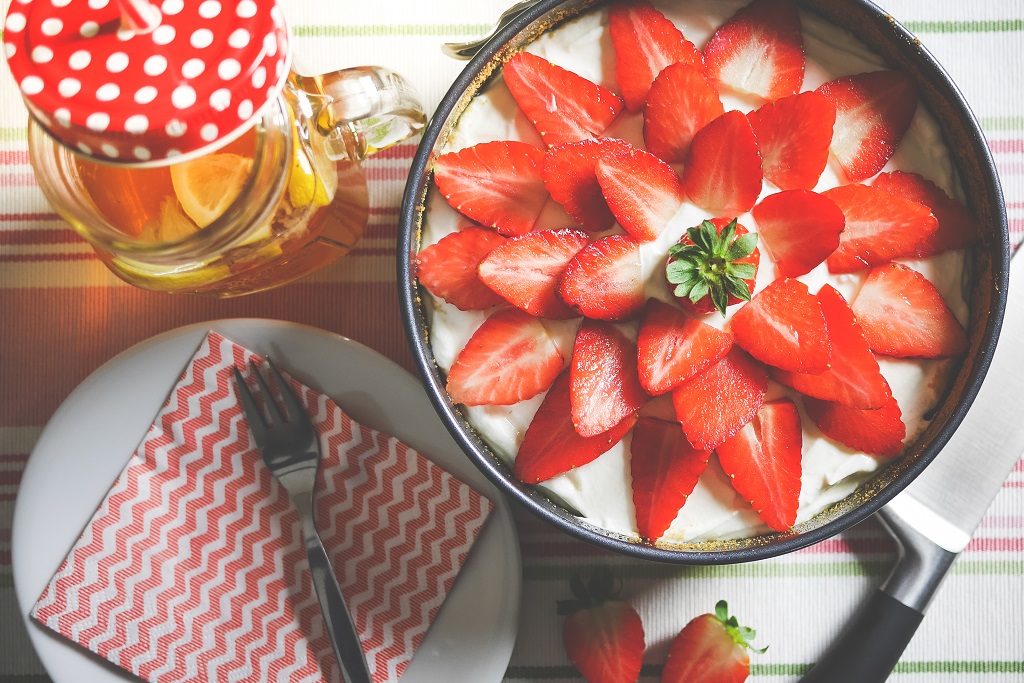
xmin=297 ymin=67 xmax=427 ymax=161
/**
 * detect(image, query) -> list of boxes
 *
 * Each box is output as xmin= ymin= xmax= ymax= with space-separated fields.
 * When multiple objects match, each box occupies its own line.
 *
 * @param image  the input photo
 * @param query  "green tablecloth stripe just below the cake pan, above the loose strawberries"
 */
xmin=522 ymin=558 xmax=1024 ymax=581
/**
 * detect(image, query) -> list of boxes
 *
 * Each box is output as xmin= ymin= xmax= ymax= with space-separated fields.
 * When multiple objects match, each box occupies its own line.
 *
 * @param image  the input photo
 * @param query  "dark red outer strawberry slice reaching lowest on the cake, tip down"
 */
xmin=630 ymin=418 xmax=711 ymax=542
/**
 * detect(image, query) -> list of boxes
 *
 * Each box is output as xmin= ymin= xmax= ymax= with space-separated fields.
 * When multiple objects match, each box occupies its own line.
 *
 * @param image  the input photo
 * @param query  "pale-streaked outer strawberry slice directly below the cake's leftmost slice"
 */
xmin=447 ymin=308 xmax=564 ymax=405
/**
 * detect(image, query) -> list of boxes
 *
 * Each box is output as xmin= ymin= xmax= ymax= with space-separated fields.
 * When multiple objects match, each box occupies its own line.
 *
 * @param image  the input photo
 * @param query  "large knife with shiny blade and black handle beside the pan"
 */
xmin=802 ymin=258 xmax=1024 ymax=683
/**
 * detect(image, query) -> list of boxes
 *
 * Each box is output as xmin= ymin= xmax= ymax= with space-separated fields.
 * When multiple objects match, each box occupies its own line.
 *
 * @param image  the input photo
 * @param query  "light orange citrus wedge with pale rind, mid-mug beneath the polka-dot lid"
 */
xmin=171 ymin=154 xmax=253 ymax=227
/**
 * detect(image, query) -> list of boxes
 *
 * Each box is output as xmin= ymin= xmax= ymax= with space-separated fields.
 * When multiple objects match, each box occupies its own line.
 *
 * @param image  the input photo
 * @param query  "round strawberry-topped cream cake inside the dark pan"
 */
xmin=417 ymin=0 xmax=978 ymax=547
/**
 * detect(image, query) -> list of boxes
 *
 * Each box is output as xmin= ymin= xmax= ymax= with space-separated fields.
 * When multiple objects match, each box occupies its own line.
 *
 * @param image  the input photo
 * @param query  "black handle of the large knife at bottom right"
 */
xmin=803 ymin=590 xmax=925 ymax=683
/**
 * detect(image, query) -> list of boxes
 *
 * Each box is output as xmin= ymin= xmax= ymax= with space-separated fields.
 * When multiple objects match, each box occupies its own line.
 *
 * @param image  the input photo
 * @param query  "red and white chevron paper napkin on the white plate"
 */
xmin=32 ymin=333 xmax=492 ymax=683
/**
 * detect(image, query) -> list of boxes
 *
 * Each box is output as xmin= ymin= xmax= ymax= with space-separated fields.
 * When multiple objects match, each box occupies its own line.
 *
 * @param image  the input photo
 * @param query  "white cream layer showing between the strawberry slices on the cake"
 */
xmin=422 ymin=0 xmax=969 ymax=544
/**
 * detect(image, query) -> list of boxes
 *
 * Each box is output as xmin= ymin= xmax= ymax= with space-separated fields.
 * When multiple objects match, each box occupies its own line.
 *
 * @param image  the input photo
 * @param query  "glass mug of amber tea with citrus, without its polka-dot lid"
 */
xmin=29 ymin=67 xmax=426 ymax=297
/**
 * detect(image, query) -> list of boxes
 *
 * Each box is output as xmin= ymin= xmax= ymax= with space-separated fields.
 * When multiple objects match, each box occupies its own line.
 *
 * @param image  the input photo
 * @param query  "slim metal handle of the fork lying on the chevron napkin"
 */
xmin=299 ymin=496 xmax=372 ymax=683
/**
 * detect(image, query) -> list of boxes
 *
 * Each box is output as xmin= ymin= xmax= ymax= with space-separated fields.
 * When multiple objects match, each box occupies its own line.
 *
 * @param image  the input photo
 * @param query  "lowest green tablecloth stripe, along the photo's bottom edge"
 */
xmin=505 ymin=659 xmax=1024 ymax=681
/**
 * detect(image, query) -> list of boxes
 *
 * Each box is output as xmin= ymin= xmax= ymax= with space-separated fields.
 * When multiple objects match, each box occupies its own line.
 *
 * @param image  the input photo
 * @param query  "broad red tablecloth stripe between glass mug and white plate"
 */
xmin=0 ymin=280 xmax=412 ymax=426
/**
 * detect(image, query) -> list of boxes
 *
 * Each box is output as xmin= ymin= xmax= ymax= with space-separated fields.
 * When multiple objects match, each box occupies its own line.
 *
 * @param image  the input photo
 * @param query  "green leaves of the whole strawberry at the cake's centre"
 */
xmin=665 ymin=219 xmax=758 ymax=315
